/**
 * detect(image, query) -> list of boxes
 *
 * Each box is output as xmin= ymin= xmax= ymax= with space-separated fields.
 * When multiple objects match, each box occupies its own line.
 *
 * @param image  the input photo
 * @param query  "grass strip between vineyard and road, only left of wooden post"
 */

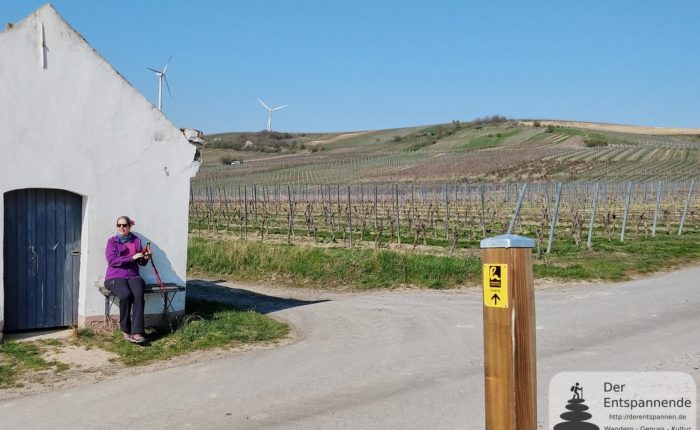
xmin=188 ymin=237 xmax=481 ymax=289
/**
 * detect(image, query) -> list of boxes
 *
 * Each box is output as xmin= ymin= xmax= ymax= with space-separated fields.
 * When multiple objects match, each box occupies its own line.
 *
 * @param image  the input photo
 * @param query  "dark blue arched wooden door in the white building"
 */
xmin=3 ymin=188 xmax=82 ymax=332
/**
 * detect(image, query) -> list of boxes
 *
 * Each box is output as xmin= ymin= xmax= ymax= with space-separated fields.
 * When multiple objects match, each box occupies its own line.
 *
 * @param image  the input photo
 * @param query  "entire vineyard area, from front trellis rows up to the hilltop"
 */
xmin=190 ymin=119 xmax=700 ymax=252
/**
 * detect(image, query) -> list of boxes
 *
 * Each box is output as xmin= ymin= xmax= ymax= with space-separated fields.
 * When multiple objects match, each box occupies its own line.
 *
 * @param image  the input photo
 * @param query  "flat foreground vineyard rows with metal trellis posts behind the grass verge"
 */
xmin=190 ymin=180 xmax=700 ymax=253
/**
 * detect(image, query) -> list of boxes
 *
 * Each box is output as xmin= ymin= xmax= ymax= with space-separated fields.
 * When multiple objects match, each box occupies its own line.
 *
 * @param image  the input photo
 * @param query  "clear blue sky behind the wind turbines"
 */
xmin=0 ymin=0 xmax=700 ymax=133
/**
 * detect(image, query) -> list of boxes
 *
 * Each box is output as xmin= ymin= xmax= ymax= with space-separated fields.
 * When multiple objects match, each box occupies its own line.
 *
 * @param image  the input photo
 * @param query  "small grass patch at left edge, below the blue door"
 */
xmin=0 ymin=341 xmax=68 ymax=388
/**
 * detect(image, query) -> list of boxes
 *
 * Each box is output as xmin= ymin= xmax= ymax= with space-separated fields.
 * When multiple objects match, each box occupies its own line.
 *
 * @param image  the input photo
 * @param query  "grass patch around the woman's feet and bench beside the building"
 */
xmin=76 ymin=297 xmax=289 ymax=366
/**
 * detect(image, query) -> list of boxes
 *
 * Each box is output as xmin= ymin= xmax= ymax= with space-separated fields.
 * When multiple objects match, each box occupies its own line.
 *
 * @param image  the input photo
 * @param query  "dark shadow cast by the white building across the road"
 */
xmin=187 ymin=279 xmax=329 ymax=314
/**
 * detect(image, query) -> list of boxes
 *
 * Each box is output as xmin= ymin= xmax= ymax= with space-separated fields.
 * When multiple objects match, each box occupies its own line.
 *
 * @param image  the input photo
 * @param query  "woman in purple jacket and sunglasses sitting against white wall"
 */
xmin=105 ymin=216 xmax=150 ymax=343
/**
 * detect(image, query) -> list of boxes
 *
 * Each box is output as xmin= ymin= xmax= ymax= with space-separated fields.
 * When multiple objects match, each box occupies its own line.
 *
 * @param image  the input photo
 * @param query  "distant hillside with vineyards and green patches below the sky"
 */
xmin=194 ymin=117 xmax=700 ymax=185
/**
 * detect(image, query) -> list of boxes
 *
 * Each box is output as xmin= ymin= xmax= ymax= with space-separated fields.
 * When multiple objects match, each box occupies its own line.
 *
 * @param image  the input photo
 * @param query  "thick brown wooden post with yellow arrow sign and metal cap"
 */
xmin=481 ymin=235 xmax=537 ymax=430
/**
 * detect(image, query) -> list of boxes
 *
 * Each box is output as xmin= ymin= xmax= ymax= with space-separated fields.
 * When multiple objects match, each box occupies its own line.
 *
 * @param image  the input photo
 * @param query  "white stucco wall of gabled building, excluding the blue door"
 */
xmin=0 ymin=5 xmax=198 ymax=330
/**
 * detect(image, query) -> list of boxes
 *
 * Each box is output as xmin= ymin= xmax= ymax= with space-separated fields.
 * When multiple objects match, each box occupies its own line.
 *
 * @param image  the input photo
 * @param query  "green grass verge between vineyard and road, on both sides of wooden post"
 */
xmin=188 ymin=233 xmax=700 ymax=289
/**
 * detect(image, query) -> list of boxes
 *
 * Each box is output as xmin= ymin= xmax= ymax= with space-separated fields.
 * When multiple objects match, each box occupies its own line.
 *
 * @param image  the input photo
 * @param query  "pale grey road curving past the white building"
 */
xmin=0 ymin=267 xmax=700 ymax=430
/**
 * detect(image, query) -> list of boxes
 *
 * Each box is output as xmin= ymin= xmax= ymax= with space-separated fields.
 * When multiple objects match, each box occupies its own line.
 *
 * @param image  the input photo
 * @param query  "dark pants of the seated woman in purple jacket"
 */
xmin=105 ymin=277 xmax=146 ymax=334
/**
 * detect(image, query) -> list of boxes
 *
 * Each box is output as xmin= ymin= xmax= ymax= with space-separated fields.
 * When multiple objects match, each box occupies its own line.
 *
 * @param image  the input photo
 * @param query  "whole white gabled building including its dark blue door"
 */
xmin=0 ymin=5 xmax=199 ymax=336
